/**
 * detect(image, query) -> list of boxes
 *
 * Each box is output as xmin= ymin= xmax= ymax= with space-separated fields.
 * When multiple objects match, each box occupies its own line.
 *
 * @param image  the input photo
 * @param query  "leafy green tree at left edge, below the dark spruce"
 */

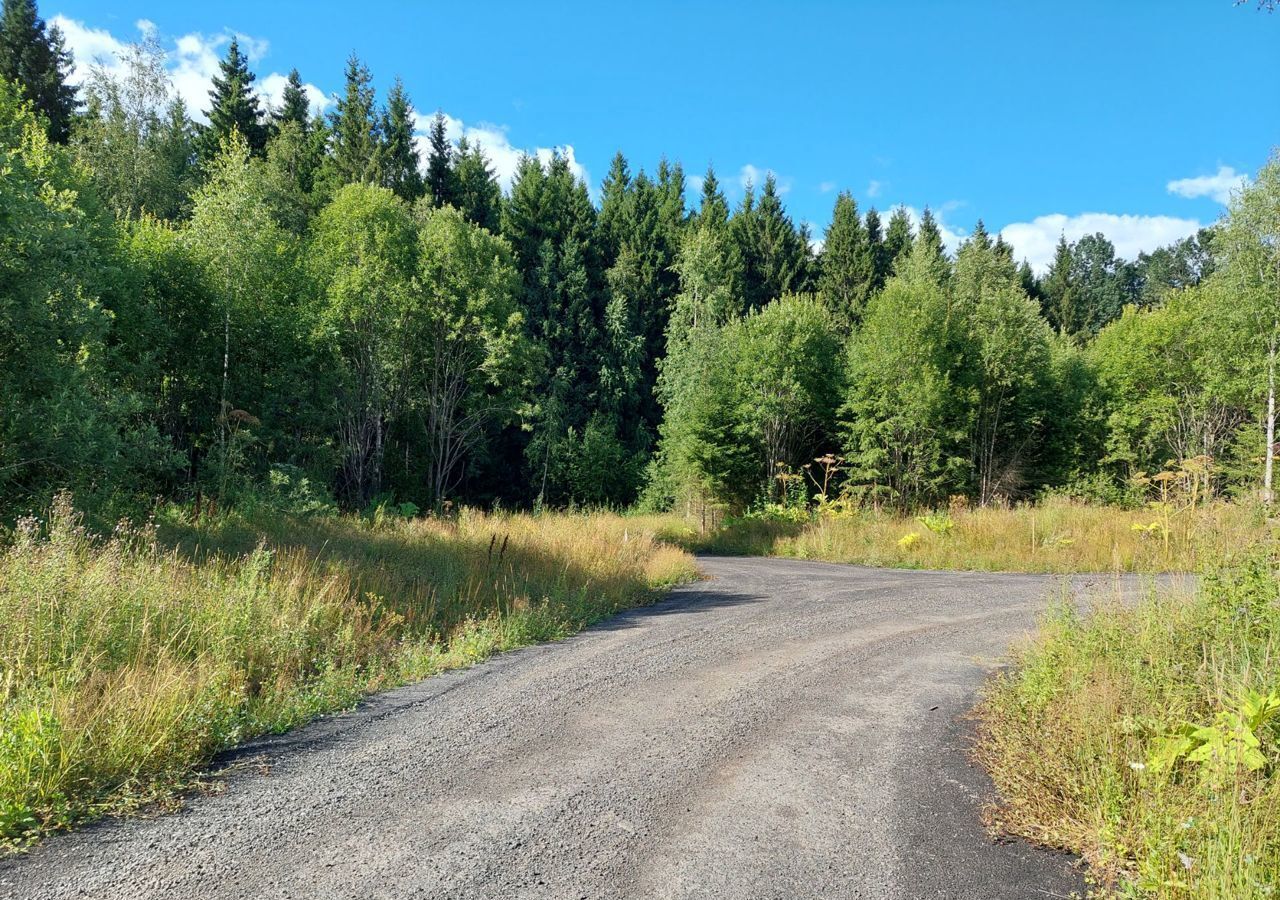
xmin=0 ymin=83 xmax=120 ymax=503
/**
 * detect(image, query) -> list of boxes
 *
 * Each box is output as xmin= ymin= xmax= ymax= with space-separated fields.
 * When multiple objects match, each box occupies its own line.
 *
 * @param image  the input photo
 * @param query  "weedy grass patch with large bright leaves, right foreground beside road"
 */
xmin=979 ymin=549 xmax=1280 ymax=900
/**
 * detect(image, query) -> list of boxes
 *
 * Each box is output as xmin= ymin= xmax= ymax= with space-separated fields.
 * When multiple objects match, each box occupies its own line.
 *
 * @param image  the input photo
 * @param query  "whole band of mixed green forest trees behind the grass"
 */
xmin=0 ymin=0 xmax=1280 ymax=510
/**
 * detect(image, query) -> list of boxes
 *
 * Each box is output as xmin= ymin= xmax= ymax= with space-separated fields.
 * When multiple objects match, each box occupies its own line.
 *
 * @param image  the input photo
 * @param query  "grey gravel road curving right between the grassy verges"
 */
xmin=0 ymin=558 xmax=1141 ymax=900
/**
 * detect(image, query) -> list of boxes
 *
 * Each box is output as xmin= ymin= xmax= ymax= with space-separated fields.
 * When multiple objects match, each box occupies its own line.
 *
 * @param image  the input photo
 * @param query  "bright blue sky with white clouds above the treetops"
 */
xmin=49 ymin=0 xmax=1280 ymax=264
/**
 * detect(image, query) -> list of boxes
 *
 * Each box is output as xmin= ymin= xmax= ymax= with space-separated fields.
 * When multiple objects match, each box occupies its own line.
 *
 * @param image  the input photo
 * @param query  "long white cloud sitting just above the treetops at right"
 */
xmin=1000 ymin=213 xmax=1201 ymax=273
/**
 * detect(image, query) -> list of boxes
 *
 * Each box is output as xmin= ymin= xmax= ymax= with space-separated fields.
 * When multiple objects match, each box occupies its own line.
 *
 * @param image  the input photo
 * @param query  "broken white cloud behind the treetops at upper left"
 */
xmin=50 ymin=15 xmax=330 ymax=122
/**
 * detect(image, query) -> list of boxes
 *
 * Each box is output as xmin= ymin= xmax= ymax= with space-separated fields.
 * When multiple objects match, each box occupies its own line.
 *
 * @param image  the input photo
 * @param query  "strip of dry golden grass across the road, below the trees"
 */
xmin=667 ymin=501 xmax=1263 ymax=574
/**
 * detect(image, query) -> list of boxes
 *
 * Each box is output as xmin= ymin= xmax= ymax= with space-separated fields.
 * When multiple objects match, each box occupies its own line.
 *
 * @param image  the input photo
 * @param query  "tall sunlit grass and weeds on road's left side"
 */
xmin=0 ymin=501 xmax=694 ymax=846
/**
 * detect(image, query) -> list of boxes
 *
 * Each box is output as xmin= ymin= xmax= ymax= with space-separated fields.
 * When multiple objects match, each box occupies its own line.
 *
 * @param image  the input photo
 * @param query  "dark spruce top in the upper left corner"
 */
xmin=0 ymin=0 xmax=78 ymax=143
